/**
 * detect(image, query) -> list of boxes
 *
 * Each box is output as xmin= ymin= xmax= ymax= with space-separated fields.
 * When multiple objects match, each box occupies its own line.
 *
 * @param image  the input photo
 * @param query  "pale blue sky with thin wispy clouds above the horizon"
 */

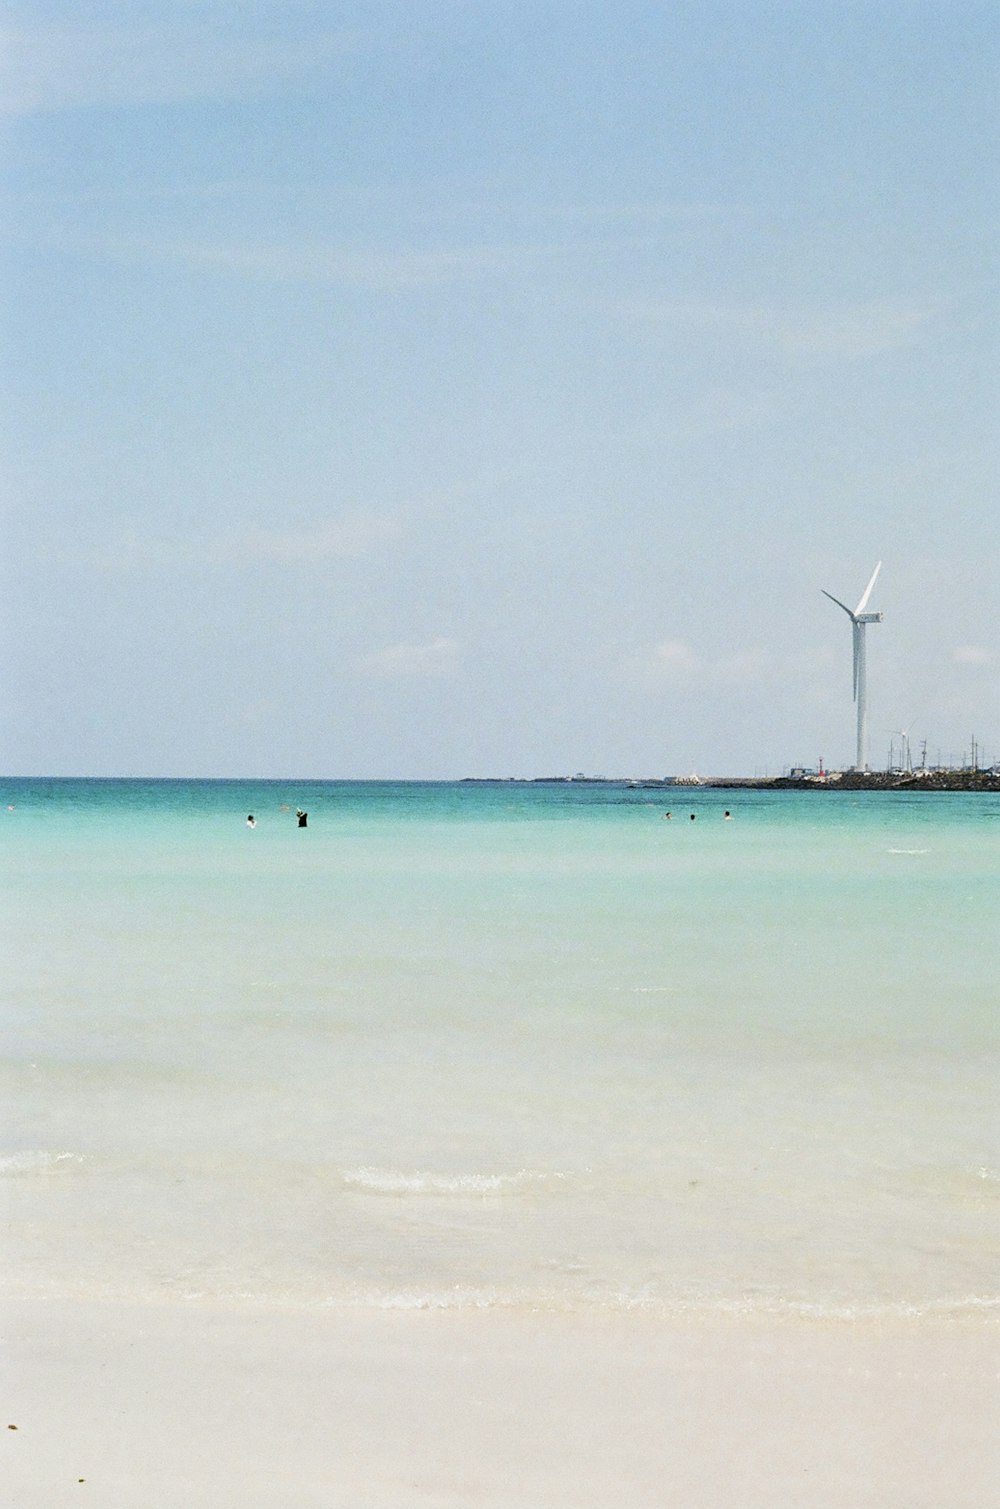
xmin=0 ymin=0 xmax=1000 ymax=779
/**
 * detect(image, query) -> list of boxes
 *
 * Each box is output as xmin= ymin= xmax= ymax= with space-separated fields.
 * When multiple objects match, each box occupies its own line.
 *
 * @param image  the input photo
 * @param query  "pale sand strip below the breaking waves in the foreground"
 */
xmin=0 ymin=1299 xmax=1000 ymax=1509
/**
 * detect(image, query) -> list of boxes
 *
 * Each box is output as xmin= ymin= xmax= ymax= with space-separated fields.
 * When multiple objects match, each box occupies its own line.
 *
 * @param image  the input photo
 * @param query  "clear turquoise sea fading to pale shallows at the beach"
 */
xmin=0 ymin=779 xmax=1000 ymax=1320
